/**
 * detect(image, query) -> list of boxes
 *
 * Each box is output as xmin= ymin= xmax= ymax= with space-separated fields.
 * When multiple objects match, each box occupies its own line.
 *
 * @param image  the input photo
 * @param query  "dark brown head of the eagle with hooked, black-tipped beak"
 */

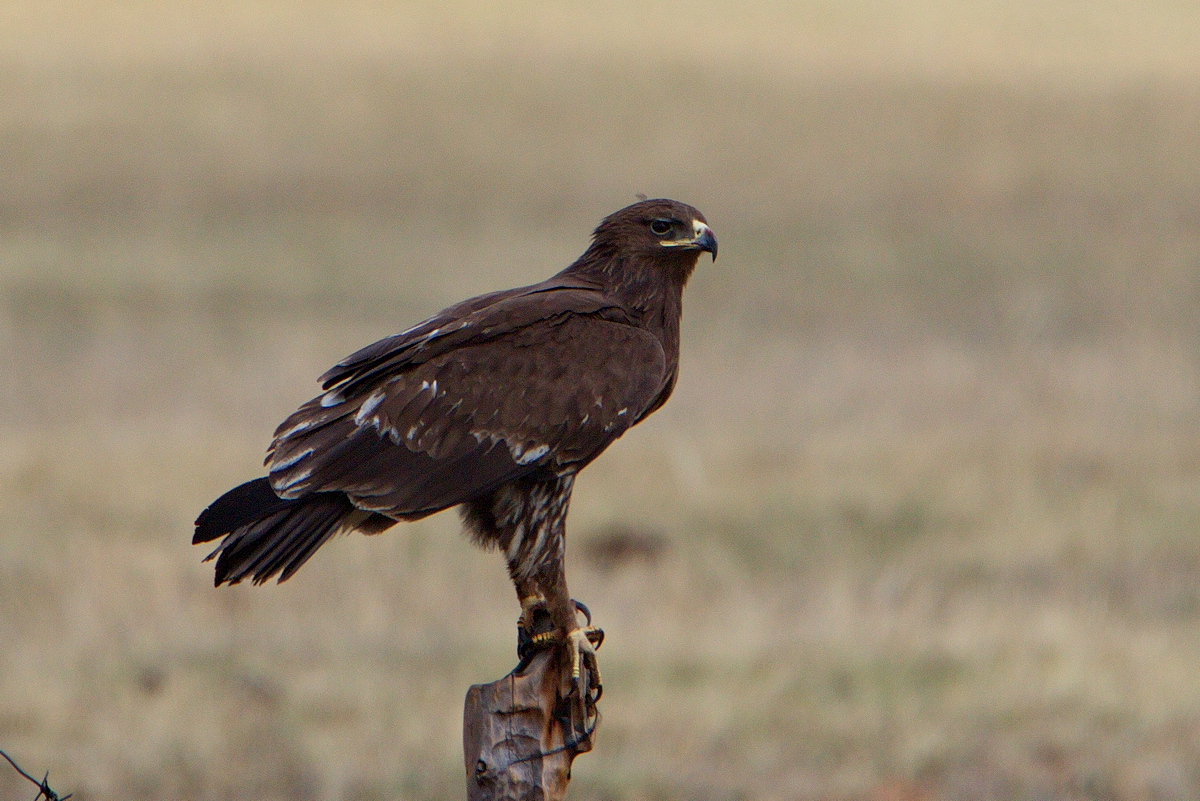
xmin=592 ymin=198 xmax=716 ymax=262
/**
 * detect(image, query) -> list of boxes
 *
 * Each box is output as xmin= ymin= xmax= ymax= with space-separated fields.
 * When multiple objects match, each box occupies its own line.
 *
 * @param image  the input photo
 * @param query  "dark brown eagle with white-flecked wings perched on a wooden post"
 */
xmin=192 ymin=199 xmax=716 ymax=685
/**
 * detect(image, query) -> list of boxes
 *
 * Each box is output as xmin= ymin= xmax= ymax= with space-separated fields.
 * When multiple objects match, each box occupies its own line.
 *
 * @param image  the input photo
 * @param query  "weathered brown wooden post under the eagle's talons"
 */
xmin=462 ymin=645 xmax=599 ymax=801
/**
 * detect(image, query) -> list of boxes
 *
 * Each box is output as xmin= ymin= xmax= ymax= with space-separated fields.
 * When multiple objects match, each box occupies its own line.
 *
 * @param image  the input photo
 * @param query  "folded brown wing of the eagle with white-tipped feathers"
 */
xmin=266 ymin=299 xmax=670 ymax=519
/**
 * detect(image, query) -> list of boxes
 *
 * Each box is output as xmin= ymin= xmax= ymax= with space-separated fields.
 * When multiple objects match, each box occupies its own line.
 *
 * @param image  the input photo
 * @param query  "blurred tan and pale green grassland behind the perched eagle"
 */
xmin=0 ymin=0 xmax=1200 ymax=801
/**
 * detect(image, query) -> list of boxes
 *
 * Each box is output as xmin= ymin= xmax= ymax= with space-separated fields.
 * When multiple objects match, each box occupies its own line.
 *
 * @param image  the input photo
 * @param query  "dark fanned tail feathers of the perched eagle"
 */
xmin=192 ymin=478 xmax=355 ymax=586
